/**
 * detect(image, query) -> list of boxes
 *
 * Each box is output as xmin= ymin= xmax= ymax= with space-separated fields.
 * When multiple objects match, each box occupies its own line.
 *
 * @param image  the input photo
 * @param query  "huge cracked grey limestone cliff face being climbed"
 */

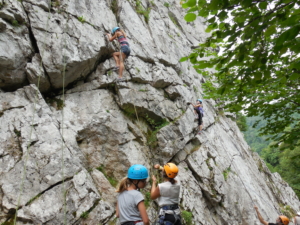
xmin=0 ymin=0 xmax=300 ymax=225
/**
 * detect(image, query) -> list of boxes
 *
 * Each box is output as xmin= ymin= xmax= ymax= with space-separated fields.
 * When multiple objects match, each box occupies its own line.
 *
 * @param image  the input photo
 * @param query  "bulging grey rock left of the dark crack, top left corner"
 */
xmin=0 ymin=0 xmax=34 ymax=90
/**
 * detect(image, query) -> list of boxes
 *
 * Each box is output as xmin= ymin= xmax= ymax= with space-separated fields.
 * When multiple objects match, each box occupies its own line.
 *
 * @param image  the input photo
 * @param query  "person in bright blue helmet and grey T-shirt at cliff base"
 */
xmin=116 ymin=164 xmax=150 ymax=225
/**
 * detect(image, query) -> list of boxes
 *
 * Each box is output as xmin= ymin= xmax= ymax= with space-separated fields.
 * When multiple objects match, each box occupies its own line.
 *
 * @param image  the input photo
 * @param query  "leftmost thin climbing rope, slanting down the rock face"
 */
xmin=13 ymin=0 xmax=52 ymax=225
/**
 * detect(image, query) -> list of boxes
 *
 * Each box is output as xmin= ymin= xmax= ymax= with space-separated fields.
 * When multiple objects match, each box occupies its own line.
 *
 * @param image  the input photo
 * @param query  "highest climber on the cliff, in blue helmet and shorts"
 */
xmin=107 ymin=27 xmax=130 ymax=79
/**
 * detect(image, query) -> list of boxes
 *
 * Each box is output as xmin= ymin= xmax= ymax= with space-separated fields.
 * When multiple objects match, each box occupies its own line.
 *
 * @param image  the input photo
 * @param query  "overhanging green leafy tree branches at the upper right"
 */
xmin=181 ymin=0 xmax=300 ymax=148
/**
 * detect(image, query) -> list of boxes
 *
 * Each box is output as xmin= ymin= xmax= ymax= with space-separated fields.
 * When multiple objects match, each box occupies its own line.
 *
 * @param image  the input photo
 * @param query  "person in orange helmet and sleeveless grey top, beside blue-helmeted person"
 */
xmin=150 ymin=163 xmax=182 ymax=225
